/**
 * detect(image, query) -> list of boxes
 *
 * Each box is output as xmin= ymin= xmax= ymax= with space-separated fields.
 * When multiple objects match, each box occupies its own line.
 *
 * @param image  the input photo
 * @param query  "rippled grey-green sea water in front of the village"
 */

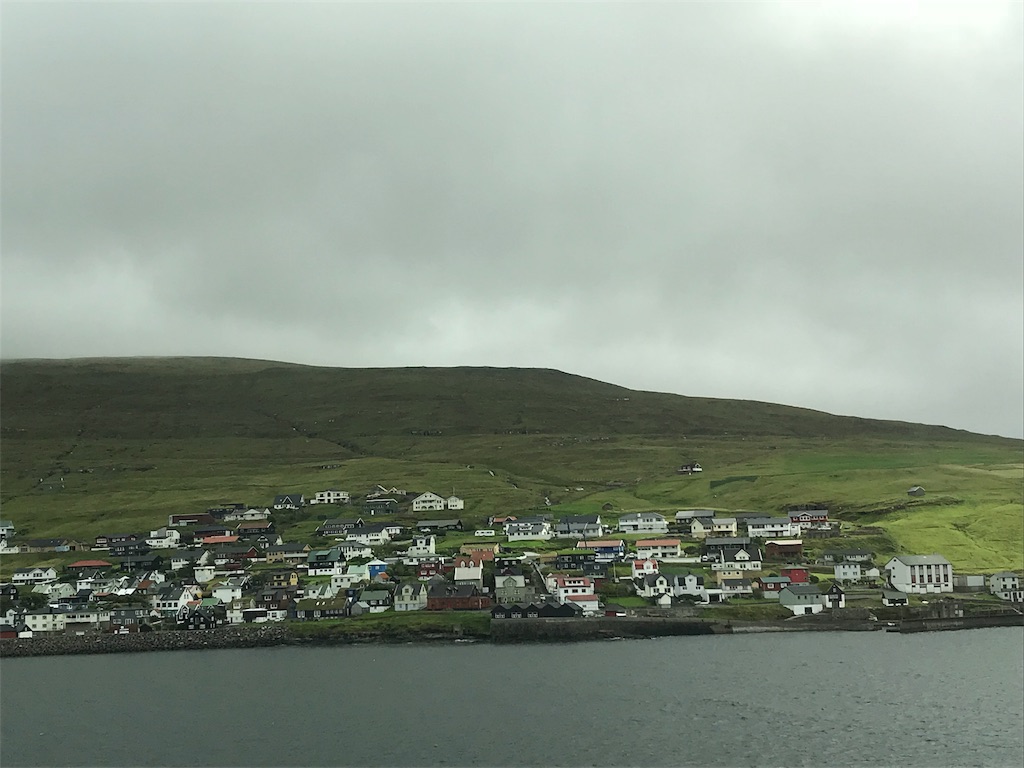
xmin=0 ymin=628 xmax=1024 ymax=768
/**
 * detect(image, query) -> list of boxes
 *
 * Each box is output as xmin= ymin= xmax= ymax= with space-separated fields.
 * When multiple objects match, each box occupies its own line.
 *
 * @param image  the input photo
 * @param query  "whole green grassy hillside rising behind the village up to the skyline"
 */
xmin=0 ymin=358 xmax=1024 ymax=570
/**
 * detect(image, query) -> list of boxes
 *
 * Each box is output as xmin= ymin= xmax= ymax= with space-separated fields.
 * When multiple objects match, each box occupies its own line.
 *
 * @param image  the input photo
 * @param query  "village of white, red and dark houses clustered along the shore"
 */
xmin=0 ymin=481 xmax=1024 ymax=639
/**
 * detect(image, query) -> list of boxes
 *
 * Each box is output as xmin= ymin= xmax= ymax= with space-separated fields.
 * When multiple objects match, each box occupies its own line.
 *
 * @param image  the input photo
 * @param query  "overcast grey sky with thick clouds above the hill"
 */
xmin=0 ymin=0 xmax=1024 ymax=437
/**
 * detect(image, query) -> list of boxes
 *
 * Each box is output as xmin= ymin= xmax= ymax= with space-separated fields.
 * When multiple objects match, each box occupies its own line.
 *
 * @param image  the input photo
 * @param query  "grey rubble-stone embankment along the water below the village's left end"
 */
xmin=0 ymin=625 xmax=291 ymax=656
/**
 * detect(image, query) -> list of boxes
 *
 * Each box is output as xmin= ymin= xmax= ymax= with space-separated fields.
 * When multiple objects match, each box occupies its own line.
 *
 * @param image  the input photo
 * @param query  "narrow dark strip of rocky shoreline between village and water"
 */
xmin=0 ymin=613 xmax=1024 ymax=658
